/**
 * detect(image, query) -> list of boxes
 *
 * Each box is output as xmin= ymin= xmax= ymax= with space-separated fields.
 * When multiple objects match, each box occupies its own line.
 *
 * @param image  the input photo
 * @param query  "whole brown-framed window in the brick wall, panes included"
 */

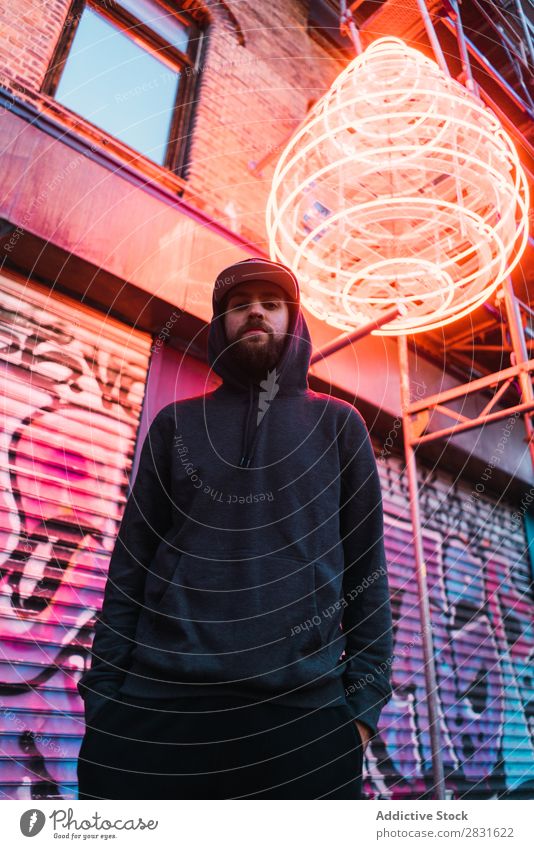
xmin=44 ymin=0 xmax=203 ymax=173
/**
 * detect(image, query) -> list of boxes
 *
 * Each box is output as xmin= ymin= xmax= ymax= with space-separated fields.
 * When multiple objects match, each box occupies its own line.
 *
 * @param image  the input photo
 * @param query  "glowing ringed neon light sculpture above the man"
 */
xmin=267 ymin=38 xmax=528 ymax=336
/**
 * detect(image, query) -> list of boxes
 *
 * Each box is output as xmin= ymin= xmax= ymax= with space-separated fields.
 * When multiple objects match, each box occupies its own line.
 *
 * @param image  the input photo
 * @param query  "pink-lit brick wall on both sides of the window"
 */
xmin=0 ymin=0 xmax=341 ymax=247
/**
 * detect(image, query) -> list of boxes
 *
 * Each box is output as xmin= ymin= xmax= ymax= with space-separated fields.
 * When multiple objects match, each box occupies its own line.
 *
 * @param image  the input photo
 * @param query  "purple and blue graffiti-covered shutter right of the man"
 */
xmin=372 ymin=459 xmax=534 ymax=799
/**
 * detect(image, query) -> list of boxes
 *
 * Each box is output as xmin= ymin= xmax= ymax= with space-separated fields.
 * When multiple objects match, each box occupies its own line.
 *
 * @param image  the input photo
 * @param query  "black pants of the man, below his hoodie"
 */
xmin=78 ymin=696 xmax=363 ymax=799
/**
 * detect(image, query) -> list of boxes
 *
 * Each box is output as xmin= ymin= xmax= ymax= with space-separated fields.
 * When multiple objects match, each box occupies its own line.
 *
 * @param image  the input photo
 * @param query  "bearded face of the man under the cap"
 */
xmin=224 ymin=280 xmax=289 ymax=380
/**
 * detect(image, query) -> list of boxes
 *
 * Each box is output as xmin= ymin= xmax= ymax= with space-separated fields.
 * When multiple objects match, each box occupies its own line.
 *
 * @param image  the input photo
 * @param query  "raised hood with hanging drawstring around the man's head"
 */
xmin=208 ymin=266 xmax=312 ymax=466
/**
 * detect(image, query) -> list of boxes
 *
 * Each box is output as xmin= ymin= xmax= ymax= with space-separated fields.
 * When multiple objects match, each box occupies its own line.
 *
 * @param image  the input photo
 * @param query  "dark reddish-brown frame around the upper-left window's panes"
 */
xmin=41 ymin=0 xmax=209 ymax=179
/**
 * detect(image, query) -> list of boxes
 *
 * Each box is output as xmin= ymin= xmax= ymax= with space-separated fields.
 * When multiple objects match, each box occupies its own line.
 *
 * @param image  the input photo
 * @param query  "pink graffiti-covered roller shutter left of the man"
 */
xmin=0 ymin=277 xmax=150 ymax=799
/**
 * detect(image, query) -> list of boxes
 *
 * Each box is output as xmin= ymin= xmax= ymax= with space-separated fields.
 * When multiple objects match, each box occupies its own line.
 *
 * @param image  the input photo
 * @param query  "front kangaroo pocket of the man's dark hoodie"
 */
xmin=136 ymin=552 xmax=322 ymax=688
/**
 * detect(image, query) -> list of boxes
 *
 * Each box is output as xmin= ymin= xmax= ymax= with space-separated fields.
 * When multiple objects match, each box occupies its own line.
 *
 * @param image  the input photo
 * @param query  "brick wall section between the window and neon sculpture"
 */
xmin=183 ymin=0 xmax=342 ymax=247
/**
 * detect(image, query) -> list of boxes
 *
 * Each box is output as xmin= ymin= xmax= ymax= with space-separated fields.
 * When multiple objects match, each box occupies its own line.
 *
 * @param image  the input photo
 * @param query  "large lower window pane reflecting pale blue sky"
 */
xmin=55 ymin=8 xmax=180 ymax=165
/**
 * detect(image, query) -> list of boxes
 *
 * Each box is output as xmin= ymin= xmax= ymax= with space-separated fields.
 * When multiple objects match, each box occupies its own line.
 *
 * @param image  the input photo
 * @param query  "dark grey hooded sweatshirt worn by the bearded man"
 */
xmin=78 ymin=274 xmax=398 ymax=730
